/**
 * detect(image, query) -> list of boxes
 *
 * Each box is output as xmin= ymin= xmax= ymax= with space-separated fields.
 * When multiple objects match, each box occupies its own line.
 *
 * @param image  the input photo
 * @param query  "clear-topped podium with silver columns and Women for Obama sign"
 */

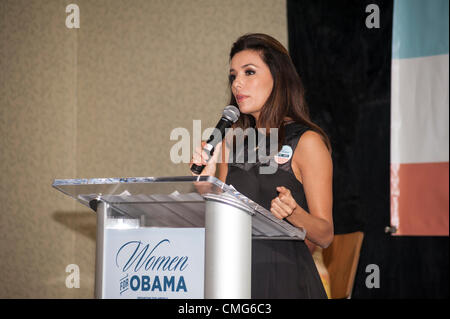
xmin=52 ymin=176 xmax=306 ymax=299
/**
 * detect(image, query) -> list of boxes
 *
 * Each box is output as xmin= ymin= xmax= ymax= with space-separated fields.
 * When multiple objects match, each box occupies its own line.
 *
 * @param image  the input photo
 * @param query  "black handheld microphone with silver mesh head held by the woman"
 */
xmin=191 ymin=105 xmax=241 ymax=175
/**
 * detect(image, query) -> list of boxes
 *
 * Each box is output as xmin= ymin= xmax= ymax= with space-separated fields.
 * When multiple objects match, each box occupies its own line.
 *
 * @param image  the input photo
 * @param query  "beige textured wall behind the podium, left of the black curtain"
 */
xmin=0 ymin=0 xmax=287 ymax=298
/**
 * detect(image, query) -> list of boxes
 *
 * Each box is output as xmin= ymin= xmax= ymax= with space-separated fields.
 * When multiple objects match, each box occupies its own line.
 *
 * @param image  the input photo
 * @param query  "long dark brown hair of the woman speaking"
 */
xmin=229 ymin=33 xmax=331 ymax=152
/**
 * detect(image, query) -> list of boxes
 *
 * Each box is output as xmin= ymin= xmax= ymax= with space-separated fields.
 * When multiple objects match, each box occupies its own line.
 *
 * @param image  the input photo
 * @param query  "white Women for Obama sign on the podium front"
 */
xmin=102 ymin=227 xmax=205 ymax=299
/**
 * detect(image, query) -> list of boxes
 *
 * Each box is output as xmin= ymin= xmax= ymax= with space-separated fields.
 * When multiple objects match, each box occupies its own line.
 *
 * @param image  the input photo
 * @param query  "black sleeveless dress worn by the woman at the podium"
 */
xmin=226 ymin=123 xmax=327 ymax=299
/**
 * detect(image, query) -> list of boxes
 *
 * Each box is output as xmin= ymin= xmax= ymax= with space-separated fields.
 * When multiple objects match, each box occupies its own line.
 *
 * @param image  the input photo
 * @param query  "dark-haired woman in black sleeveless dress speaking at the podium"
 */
xmin=188 ymin=34 xmax=333 ymax=298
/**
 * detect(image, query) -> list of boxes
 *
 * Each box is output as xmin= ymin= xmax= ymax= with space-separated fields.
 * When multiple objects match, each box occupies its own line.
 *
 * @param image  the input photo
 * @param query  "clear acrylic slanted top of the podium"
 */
xmin=52 ymin=176 xmax=306 ymax=240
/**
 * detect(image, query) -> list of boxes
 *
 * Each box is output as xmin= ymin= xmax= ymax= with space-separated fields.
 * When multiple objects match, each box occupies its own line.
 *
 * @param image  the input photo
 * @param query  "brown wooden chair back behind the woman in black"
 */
xmin=323 ymin=232 xmax=364 ymax=299
